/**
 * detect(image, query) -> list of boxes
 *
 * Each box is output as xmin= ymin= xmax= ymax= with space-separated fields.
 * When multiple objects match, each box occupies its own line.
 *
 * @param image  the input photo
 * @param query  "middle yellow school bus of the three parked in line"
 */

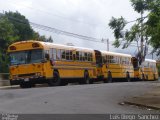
xmin=96 ymin=51 xmax=134 ymax=82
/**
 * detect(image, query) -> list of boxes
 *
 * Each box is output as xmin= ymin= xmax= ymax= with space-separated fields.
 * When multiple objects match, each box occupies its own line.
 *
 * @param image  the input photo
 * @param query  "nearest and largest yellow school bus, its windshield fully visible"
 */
xmin=8 ymin=40 xmax=97 ymax=88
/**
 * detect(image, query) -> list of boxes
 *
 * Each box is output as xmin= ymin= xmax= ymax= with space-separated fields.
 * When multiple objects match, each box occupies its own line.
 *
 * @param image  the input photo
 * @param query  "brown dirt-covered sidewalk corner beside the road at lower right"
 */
xmin=124 ymin=82 xmax=160 ymax=110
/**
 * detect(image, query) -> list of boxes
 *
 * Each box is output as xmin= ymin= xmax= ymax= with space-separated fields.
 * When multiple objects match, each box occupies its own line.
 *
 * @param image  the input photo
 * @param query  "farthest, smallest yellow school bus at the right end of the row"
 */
xmin=132 ymin=57 xmax=158 ymax=81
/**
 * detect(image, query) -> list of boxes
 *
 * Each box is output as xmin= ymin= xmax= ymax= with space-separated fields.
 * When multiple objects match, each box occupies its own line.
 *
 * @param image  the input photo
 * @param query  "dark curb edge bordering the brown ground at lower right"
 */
xmin=124 ymin=101 xmax=160 ymax=110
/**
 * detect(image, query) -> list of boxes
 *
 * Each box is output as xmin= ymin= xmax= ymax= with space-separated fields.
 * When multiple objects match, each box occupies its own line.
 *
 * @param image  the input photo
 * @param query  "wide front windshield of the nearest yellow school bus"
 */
xmin=10 ymin=49 xmax=44 ymax=65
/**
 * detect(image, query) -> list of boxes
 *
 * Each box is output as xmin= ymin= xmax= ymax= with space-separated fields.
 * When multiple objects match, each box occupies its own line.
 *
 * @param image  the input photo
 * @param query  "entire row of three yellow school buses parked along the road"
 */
xmin=8 ymin=40 xmax=158 ymax=88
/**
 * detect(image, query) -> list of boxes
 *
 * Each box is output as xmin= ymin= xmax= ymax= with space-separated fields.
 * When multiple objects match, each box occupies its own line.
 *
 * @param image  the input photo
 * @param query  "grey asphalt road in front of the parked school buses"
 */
xmin=0 ymin=82 xmax=160 ymax=114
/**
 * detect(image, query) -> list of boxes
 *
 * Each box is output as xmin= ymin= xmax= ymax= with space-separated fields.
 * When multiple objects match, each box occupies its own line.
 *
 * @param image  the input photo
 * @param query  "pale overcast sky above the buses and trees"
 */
xmin=0 ymin=0 xmax=156 ymax=58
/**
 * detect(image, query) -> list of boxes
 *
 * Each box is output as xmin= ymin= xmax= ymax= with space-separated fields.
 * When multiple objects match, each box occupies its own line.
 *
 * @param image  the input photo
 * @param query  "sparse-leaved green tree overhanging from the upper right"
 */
xmin=109 ymin=0 xmax=160 ymax=64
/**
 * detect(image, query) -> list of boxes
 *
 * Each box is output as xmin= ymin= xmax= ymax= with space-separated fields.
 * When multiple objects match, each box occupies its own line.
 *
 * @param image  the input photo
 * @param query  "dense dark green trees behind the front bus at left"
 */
xmin=0 ymin=11 xmax=53 ymax=72
